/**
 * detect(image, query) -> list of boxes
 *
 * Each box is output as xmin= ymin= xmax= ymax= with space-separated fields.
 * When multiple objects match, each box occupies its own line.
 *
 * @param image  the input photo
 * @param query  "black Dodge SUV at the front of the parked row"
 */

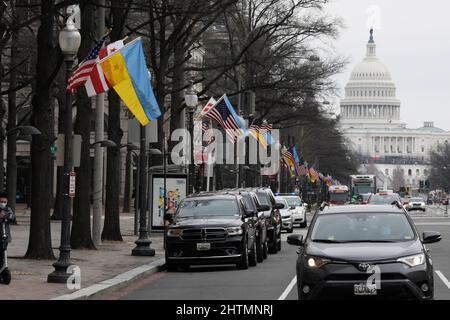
xmin=165 ymin=194 xmax=257 ymax=271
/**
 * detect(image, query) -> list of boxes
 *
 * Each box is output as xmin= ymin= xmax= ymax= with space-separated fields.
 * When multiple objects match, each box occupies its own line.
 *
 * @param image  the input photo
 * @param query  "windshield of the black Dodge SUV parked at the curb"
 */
xmin=176 ymin=199 xmax=240 ymax=218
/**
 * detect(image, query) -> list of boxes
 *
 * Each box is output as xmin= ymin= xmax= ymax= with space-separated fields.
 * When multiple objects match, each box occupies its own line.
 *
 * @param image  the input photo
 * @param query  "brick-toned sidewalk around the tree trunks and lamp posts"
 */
xmin=0 ymin=205 xmax=164 ymax=300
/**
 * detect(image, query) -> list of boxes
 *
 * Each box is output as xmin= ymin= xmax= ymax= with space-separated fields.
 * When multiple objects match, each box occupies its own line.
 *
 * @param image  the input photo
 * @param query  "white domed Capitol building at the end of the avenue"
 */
xmin=340 ymin=30 xmax=450 ymax=189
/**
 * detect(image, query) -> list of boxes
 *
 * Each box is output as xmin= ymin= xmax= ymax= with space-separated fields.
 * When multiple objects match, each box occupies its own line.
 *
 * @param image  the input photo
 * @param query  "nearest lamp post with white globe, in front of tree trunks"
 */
xmin=47 ymin=18 xmax=81 ymax=283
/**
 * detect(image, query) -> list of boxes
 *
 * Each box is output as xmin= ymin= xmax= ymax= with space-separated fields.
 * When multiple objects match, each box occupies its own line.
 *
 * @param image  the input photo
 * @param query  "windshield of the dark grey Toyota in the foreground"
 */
xmin=311 ymin=212 xmax=415 ymax=242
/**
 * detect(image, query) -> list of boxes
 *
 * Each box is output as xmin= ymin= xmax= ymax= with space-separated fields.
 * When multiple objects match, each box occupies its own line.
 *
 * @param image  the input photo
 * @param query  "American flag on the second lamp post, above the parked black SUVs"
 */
xmin=207 ymin=95 xmax=243 ymax=143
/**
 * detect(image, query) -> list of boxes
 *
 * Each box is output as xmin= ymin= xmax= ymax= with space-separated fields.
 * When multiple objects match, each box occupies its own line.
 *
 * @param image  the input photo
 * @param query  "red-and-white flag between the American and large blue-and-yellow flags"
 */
xmin=84 ymin=40 xmax=123 ymax=97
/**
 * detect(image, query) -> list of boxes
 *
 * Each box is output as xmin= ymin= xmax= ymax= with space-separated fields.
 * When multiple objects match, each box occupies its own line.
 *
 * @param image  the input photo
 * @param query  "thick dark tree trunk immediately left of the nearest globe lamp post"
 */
xmin=25 ymin=1 xmax=62 ymax=259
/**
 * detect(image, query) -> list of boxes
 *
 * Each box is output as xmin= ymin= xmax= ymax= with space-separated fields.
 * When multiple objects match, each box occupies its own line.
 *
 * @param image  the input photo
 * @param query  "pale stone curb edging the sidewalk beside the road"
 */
xmin=50 ymin=259 xmax=165 ymax=300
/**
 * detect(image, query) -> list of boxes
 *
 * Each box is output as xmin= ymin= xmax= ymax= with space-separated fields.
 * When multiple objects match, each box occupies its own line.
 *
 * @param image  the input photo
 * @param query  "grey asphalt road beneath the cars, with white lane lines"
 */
xmin=103 ymin=207 xmax=450 ymax=300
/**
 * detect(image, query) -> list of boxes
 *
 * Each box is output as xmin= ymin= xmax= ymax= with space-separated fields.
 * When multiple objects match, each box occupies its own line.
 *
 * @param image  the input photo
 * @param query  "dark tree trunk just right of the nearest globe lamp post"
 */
xmin=70 ymin=3 xmax=95 ymax=249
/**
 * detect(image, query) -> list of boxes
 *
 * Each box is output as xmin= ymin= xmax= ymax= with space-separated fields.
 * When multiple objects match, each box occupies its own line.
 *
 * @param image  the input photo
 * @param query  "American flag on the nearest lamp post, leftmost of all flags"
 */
xmin=66 ymin=34 xmax=108 ymax=93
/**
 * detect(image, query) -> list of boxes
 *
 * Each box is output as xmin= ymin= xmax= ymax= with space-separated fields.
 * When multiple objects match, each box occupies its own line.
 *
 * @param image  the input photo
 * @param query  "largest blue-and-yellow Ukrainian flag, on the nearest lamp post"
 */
xmin=99 ymin=38 xmax=161 ymax=126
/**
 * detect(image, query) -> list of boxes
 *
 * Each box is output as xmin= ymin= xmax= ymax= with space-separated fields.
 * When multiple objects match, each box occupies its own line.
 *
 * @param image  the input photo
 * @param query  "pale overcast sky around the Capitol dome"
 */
xmin=326 ymin=0 xmax=450 ymax=131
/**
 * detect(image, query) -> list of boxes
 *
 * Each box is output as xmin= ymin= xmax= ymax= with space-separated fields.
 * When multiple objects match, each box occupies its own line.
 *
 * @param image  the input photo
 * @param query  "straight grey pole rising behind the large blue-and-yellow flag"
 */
xmin=92 ymin=0 xmax=105 ymax=246
